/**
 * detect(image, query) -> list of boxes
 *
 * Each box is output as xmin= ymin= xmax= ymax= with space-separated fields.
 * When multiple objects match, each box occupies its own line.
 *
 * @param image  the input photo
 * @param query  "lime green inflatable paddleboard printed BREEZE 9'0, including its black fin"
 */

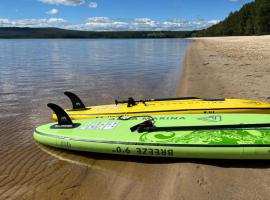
xmin=34 ymin=104 xmax=270 ymax=159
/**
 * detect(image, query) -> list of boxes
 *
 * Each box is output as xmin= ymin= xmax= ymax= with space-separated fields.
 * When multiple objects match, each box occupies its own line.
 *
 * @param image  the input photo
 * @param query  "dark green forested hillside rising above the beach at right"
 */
xmin=196 ymin=0 xmax=270 ymax=37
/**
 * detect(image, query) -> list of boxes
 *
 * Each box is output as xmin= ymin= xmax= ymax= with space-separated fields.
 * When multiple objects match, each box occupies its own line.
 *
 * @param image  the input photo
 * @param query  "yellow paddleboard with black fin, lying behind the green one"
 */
xmin=53 ymin=92 xmax=270 ymax=120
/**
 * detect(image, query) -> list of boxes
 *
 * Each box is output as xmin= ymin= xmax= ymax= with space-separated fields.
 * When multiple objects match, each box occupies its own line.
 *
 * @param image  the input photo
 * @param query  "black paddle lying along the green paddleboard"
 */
xmin=130 ymin=120 xmax=270 ymax=133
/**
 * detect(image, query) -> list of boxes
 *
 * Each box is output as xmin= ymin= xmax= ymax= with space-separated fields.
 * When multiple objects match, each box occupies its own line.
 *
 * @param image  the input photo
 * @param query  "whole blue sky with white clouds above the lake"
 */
xmin=0 ymin=0 xmax=253 ymax=31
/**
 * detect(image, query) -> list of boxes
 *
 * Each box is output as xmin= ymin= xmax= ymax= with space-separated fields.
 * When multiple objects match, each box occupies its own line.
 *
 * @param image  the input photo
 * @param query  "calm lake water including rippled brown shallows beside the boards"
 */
xmin=0 ymin=39 xmax=190 ymax=199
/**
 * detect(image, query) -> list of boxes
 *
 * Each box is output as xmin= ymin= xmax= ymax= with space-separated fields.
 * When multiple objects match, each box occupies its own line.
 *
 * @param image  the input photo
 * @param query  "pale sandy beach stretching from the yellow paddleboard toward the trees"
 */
xmin=176 ymin=36 xmax=270 ymax=101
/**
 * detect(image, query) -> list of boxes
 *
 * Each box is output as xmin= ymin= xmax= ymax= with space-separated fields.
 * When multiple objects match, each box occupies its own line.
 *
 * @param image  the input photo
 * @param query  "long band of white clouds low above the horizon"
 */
xmin=0 ymin=17 xmax=219 ymax=31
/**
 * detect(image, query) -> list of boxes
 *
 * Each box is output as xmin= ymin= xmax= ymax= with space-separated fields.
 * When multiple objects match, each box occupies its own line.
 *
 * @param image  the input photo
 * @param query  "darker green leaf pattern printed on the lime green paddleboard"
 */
xmin=140 ymin=129 xmax=270 ymax=145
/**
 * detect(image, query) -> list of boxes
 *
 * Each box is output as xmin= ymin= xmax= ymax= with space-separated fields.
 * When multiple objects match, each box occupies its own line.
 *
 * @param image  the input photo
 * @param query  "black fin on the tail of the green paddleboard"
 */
xmin=47 ymin=103 xmax=78 ymax=128
